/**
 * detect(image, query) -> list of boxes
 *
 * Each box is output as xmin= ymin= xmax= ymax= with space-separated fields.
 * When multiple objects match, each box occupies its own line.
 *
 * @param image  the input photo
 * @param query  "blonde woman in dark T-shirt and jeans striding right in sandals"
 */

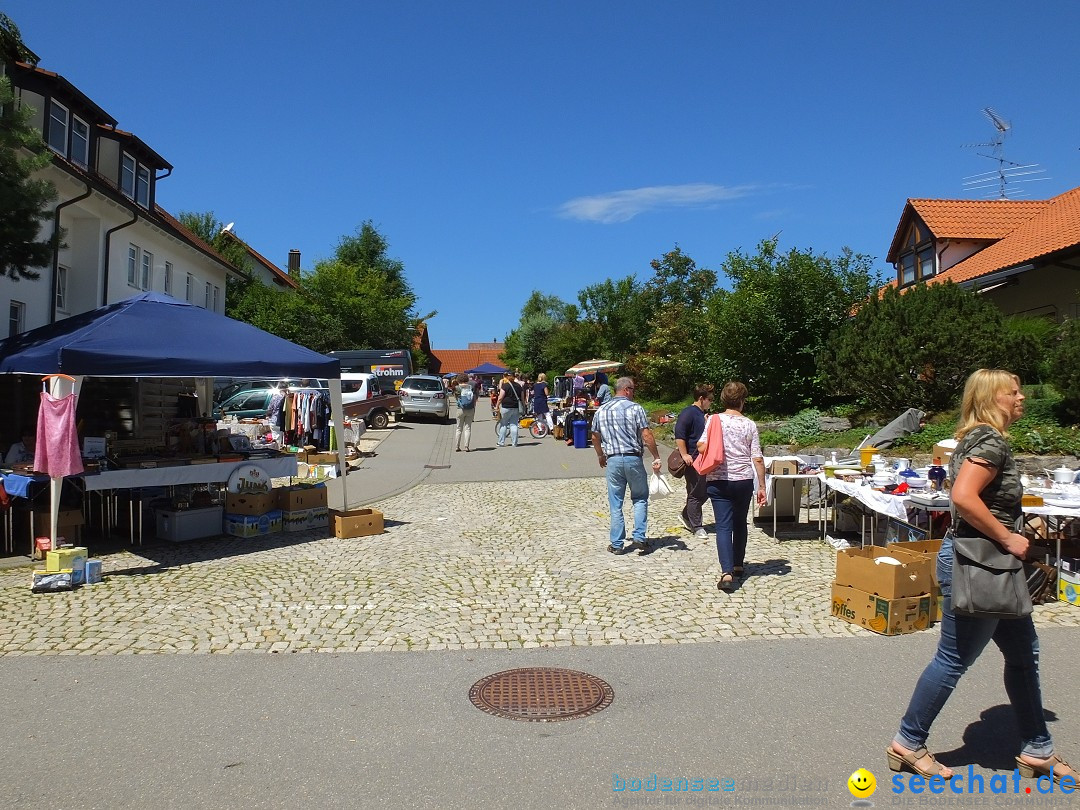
xmin=886 ymin=368 xmax=1080 ymax=784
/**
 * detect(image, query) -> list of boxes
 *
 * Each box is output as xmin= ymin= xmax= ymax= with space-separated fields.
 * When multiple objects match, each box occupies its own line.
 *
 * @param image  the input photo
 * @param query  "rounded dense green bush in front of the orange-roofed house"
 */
xmin=823 ymin=283 xmax=1010 ymax=411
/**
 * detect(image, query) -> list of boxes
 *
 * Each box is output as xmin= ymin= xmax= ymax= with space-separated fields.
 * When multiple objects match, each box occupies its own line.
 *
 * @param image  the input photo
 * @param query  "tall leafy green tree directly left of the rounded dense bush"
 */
xmin=708 ymin=240 xmax=878 ymax=413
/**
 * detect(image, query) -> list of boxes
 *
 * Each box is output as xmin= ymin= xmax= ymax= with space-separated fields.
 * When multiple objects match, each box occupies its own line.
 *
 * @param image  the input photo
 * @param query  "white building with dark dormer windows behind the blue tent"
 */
xmin=0 ymin=63 xmax=238 ymax=337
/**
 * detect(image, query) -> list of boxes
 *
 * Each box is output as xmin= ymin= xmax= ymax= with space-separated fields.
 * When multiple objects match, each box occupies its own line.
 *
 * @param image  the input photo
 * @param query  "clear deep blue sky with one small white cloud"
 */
xmin=2 ymin=0 xmax=1080 ymax=349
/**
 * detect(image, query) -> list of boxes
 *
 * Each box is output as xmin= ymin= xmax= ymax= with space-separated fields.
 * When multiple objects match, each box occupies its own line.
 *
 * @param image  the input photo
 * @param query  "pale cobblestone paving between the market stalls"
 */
xmin=0 ymin=476 xmax=1080 ymax=656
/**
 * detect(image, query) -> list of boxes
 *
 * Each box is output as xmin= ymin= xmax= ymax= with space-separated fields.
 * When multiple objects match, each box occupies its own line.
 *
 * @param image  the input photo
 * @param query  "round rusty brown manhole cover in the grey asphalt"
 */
xmin=469 ymin=666 xmax=615 ymax=723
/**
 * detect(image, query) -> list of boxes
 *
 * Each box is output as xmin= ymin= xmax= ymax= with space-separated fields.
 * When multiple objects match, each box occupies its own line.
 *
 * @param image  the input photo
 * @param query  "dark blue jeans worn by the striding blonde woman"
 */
xmin=895 ymin=532 xmax=1054 ymax=759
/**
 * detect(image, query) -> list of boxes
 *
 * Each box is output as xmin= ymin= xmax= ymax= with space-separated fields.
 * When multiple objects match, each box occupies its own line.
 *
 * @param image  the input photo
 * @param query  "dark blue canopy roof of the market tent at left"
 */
xmin=0 ymin=293 xmax=341 ymax=379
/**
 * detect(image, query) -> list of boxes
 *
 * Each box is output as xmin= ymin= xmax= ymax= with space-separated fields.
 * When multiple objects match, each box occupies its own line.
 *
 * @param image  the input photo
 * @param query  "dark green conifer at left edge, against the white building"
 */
xmin=0 ymin=73 xmax=55 ymax=281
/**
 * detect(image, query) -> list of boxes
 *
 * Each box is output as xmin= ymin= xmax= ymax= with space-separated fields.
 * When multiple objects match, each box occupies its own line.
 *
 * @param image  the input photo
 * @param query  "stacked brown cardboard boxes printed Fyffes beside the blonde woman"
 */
xmin=832 ymin=543 xmax=933 ymax=636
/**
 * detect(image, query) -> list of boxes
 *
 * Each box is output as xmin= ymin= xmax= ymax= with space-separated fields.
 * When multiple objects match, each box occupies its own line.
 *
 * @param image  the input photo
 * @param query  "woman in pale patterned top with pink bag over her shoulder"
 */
xmin=698 ymin=382 xmax=765 ymax=593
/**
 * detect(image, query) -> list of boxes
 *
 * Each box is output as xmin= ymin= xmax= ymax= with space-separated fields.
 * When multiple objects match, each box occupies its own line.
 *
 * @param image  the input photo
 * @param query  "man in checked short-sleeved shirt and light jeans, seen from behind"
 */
xmin=593 ymin=377 xmax=660 ymax=554
